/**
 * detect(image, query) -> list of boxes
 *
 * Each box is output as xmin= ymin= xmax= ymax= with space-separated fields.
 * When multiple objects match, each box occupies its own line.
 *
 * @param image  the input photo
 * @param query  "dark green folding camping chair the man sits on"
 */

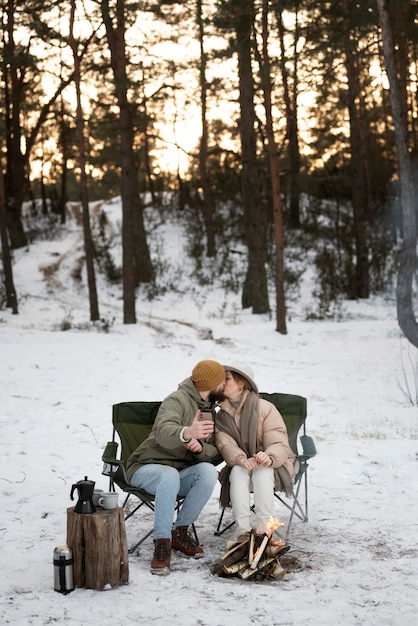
xmin=102 ymin=402 xmax=199 ymax=552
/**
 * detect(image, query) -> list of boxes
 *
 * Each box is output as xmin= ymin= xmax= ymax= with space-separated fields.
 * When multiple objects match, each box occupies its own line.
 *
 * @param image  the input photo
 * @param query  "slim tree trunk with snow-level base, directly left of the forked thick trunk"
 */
xmin=69 ymin=0 xmax=100 ymax=322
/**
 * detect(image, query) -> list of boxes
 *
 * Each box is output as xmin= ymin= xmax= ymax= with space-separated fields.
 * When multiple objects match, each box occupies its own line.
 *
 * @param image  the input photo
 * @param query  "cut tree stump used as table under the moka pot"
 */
xmin=67 ymin=507 xmax=129 ymax=590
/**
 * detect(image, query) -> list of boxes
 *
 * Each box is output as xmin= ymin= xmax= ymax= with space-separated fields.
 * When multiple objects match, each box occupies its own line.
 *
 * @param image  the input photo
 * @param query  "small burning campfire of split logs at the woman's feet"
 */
xmin=213 ymin=518 xmax=290 ymax=580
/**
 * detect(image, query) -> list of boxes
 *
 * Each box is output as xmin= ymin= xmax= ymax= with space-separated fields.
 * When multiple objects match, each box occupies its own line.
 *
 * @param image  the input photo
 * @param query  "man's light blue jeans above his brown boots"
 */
xmin=131 ymin=463 xmax=218 ymax=539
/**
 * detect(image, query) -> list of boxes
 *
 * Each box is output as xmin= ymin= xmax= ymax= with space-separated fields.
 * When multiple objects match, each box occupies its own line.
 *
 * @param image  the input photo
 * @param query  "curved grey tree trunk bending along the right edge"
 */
xmin=377 ymin=0 xmax=418 ymax=348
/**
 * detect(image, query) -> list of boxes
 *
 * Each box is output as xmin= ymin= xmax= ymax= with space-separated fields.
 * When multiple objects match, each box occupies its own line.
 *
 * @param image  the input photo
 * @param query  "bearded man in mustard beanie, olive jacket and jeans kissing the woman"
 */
xmin=127 ymin=360 xmax=225 ymax=574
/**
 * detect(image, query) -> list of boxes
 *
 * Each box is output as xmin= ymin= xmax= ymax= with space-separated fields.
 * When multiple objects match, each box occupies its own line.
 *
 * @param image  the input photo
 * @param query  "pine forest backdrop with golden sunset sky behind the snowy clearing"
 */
xmin=0 ymin=0 xmax=418 ymax=346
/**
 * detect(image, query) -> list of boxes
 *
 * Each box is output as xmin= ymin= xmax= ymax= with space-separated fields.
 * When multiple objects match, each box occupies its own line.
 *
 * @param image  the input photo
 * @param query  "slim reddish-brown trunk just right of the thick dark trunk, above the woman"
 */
xmin=261 ymin=0 xmax=287 ymax=335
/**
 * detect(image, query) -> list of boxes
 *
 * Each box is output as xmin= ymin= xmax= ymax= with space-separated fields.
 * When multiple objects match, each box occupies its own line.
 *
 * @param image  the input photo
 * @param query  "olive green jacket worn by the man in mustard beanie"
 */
xmin=126 ymin=378 xmax=222 ymax=479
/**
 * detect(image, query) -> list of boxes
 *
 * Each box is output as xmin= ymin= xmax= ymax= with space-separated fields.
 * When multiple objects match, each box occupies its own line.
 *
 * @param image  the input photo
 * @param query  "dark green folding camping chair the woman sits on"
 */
xmin=215 ymin=393 xmax=316 ymax=538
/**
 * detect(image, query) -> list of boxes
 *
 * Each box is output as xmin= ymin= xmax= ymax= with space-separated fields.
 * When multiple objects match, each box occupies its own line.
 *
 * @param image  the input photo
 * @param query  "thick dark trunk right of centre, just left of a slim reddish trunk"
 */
xmin=236 ymin=0 xmax=270 ymax=313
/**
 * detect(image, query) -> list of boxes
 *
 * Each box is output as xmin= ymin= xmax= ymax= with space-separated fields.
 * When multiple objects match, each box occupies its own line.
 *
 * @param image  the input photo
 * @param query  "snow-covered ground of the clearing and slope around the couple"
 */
xmin=0 ymin=202 xmax=418 ymax=626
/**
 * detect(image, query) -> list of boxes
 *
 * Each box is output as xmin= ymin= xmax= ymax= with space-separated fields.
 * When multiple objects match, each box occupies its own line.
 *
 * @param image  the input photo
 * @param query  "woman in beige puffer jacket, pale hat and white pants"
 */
xmin=215 ymin=363 xmax=299 ymax=541
